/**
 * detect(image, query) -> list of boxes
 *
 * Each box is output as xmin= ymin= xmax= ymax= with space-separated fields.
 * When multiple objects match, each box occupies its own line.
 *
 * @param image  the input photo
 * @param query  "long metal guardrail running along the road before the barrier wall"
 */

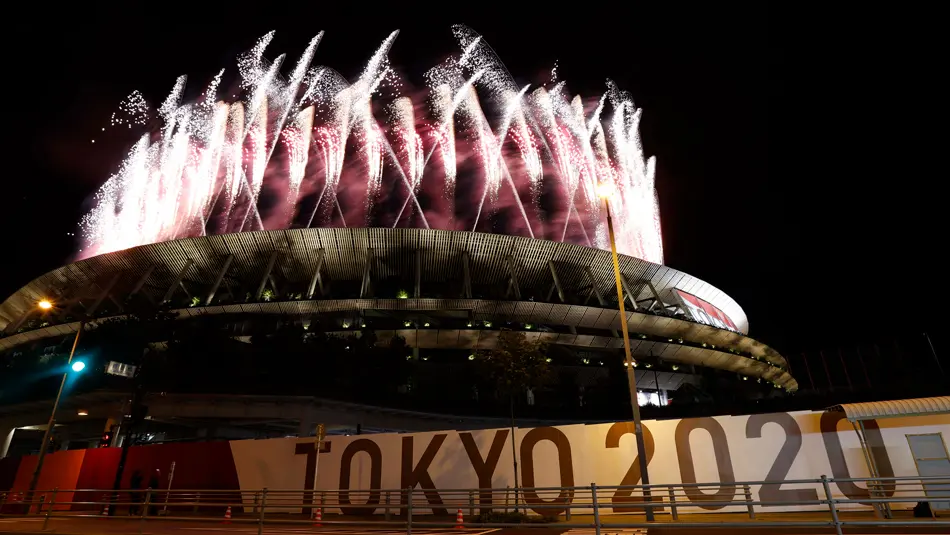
xmin=0 ymin=476 xmax=950 ymax=535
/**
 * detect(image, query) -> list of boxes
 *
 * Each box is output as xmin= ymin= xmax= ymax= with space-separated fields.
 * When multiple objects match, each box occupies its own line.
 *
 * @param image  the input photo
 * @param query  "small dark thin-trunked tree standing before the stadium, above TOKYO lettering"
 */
xmin=475 ymin=330 xmax=554 ymax=511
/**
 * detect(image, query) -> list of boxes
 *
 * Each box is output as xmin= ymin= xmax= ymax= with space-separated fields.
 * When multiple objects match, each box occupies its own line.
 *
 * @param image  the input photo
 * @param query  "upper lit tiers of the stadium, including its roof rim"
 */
xmin=0 ymin=228 xmax=798 ymax=391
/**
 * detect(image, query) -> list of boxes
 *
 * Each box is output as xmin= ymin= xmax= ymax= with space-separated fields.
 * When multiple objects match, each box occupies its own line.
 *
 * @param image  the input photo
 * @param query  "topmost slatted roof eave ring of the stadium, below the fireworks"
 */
xmin=0 ymin=228 xmax=748 ymax=334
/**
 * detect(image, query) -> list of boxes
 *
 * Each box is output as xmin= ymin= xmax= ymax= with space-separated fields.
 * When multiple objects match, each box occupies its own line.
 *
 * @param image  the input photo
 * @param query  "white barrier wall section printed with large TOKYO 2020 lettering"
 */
xmin=231 ymin=412 xmax=950 ymax=514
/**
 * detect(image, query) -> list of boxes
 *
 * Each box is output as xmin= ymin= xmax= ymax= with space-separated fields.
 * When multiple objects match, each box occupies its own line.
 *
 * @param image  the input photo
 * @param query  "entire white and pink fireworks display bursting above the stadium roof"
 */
xmin=81 ymin=26 xmax=663 ymax=262
